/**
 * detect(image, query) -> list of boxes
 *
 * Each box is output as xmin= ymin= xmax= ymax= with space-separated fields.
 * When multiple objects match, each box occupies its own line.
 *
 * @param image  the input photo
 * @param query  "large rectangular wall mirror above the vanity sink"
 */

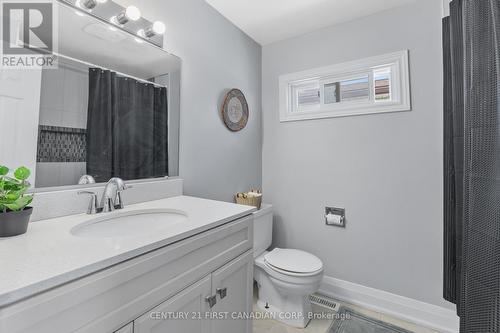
xmin=0 ymin=2 xmax=181 ymax=189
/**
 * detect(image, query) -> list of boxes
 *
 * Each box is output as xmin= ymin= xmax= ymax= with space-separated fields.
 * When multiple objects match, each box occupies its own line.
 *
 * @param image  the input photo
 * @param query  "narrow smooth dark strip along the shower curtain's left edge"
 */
xmin=443 ymin=0 xmax=464 ymax=303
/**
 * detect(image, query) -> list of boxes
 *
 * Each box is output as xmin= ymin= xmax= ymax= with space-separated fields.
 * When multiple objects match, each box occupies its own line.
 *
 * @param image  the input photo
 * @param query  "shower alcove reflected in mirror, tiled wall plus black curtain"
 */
xmin=35 ymin=57 xmax=175 ymax=187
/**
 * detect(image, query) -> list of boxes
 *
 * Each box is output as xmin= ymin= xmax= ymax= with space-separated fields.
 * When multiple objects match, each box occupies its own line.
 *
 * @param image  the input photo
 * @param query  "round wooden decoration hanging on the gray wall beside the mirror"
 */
xmin=221 ymin=89 xmax=248 ymax=132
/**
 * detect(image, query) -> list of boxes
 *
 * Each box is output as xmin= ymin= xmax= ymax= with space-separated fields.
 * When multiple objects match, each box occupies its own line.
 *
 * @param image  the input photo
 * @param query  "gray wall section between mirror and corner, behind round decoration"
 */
xmin=118 ymin=0 xmax=262 ymax=201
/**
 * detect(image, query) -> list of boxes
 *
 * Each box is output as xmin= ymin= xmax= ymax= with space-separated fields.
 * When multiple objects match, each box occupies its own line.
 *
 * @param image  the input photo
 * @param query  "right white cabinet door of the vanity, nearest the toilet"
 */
xmin=211 ymin=252 xmax=253 ymax=333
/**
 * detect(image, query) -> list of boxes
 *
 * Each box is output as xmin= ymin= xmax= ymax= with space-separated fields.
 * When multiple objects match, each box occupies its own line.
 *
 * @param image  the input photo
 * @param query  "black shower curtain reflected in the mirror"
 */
xmin=87 ymin=68 xmax=168 ymax=182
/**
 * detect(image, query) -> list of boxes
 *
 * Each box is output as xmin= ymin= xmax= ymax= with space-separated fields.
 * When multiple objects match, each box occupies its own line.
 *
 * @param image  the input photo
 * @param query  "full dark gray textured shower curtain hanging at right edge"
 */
xmin=443 ymin=0 xmax=500 ymax=333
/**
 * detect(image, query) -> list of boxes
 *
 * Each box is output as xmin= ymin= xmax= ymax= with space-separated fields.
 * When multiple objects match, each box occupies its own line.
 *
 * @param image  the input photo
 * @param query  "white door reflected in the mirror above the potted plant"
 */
xmin=0 ymin=69 xmax=42 ymax=184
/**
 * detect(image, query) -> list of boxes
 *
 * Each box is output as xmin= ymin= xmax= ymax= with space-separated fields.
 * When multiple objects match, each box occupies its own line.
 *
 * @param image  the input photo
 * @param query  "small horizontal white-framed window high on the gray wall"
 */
xmin=280 ymin=51 xmax=411 ymax=121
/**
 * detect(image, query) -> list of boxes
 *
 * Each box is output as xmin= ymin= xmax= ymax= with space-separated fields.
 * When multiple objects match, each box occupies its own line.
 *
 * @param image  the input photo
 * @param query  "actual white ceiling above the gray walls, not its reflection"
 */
xmin=206 ymin=0 xmax=415 ymax=45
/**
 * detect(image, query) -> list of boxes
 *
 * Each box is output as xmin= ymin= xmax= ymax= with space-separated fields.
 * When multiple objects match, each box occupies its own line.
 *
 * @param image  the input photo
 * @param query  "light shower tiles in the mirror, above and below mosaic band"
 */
xmin=35 ymin=63 xmax=88 ymax=187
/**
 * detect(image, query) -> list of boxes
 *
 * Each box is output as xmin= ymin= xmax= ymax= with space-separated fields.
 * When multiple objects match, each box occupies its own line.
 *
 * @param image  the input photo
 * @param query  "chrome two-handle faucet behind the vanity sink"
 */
xmin=78 ymin=177 xmax=132 ymax=214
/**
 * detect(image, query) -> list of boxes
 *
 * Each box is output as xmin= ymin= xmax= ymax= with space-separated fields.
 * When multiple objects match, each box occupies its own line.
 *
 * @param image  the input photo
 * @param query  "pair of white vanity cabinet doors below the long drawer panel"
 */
xmin=134 ymin=252 xmax=253 ymax=333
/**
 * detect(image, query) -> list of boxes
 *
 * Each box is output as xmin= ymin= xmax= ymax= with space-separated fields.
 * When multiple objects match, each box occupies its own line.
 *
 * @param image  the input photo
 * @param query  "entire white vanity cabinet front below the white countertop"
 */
xmin=0 ymin=216 xmax=253 ymax=333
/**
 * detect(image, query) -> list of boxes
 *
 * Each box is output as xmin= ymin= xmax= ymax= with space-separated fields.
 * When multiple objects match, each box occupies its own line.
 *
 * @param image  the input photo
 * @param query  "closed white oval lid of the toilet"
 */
xmin=264 ymin=248 xmax=323 ymax=273
